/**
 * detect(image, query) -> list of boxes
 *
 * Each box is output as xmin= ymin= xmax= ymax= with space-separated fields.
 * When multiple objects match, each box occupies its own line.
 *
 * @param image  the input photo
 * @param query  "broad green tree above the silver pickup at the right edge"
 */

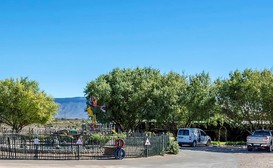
xmin=217 ymin=69 xmax=273 ymax=131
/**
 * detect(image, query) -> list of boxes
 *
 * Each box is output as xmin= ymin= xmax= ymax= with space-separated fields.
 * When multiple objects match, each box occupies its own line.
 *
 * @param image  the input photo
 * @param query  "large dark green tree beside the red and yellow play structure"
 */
xmin=85 ymin=68 xmax=159 ymax=131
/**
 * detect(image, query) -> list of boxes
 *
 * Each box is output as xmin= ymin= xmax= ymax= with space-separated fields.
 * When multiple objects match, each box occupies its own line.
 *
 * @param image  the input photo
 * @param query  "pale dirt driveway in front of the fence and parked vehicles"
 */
xmin=0 ymin=147 xmax=273 ymax=168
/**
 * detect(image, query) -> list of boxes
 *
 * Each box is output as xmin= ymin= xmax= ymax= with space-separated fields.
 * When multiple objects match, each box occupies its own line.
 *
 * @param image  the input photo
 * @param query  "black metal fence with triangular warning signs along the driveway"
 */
xmin=0 ymin=134 xmax=169 ymax=160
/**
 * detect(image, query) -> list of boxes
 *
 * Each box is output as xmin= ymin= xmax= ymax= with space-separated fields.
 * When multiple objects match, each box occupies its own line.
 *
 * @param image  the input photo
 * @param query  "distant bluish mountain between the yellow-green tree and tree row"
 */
xmin=55 ymin=97 xmax=88 ymax=119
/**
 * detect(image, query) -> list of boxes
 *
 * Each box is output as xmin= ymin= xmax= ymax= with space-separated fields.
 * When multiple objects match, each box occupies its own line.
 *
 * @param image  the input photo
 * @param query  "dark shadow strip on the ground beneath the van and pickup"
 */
xmin=180 ymin=146 xmax=273 ymax=154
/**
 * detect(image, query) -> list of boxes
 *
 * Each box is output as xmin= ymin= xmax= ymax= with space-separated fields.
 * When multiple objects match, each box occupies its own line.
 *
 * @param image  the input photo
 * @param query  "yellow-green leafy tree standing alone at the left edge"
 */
xmin=0 ymin=78 xmax=58 ymax=132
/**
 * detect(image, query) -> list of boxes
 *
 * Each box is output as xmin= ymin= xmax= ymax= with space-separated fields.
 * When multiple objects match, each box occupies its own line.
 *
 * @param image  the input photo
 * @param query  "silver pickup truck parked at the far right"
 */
xmin=247 ymin=130 xmax=272 ymax=152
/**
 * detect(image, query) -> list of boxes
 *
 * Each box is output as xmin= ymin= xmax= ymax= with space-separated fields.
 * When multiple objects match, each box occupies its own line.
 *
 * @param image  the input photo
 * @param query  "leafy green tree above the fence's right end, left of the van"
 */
xmin=147 ymin=72 xmax=187 ymax=131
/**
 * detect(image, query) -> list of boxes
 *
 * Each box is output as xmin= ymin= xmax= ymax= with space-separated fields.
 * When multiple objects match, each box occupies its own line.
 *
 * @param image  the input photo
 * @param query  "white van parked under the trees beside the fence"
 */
xmin=177 ymin=128 xmax=211 ymax=147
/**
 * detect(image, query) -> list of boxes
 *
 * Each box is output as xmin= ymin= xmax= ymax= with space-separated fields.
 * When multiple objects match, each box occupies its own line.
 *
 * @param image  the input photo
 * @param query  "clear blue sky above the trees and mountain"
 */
xmin=0 ymin=0 xmax=273 ymax=97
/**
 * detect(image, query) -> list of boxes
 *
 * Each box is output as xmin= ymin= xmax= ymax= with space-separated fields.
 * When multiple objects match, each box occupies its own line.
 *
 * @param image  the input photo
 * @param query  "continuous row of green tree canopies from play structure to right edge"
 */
xmin=85 ymin=68 xmax=273 ymax=131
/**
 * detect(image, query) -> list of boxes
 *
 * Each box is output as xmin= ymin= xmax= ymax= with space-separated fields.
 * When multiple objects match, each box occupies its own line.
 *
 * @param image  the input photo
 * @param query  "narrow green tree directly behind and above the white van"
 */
xmin=182 ymin=72 xmax=216 ymax=127
